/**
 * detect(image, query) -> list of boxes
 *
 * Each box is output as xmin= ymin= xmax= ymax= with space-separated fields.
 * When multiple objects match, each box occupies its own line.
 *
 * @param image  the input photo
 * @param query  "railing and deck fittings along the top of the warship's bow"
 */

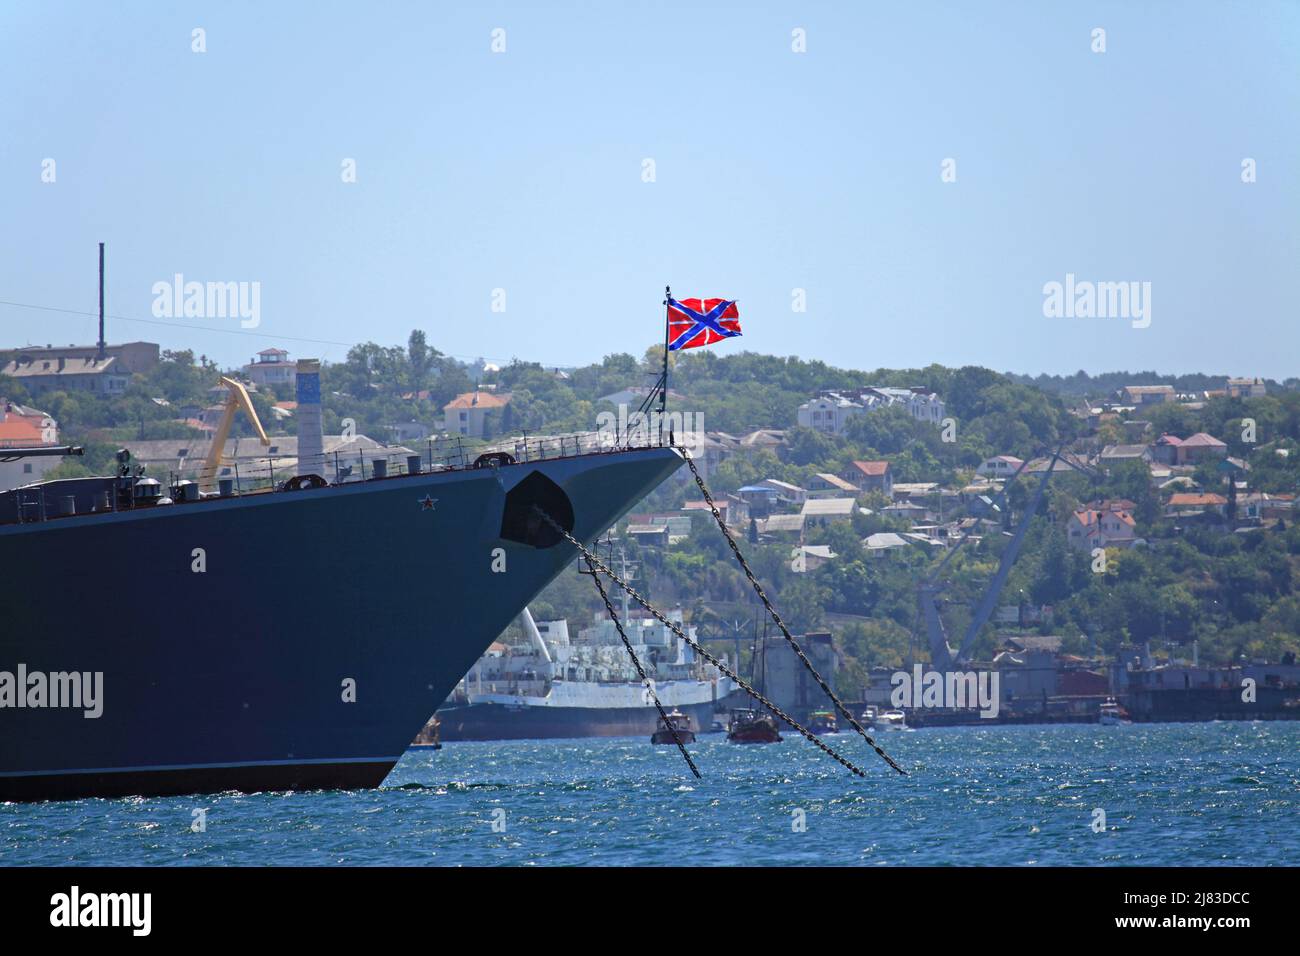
xmin=0 ymin=429 xmax=679 ymax=525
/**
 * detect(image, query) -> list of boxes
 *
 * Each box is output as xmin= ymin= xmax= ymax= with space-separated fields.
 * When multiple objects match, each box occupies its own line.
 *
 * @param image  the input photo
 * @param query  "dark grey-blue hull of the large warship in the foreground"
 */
xmin=0 ymin=449 xmax=681 ymax=800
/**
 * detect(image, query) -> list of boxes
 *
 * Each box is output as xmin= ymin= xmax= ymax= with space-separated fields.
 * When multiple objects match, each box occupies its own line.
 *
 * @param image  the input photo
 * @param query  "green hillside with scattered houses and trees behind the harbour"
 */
xmin=0 ymin=333 xmax=1300 ymax=721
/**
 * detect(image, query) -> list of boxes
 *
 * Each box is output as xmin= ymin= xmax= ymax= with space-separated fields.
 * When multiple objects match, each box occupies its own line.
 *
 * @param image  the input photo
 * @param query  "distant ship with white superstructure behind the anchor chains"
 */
xmin=437 ymin=606 xmax=736 ymax=740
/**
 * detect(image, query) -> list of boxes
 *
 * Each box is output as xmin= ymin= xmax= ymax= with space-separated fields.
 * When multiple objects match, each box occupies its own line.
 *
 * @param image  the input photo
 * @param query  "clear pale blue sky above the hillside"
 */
xmin=0 ymin=0 xmax=1300 ymax=378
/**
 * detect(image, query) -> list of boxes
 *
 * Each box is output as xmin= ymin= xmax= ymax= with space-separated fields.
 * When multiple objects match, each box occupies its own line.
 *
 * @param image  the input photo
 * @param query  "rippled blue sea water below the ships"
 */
xmin=0 ymin=723 xmax=1300 ymax=866
